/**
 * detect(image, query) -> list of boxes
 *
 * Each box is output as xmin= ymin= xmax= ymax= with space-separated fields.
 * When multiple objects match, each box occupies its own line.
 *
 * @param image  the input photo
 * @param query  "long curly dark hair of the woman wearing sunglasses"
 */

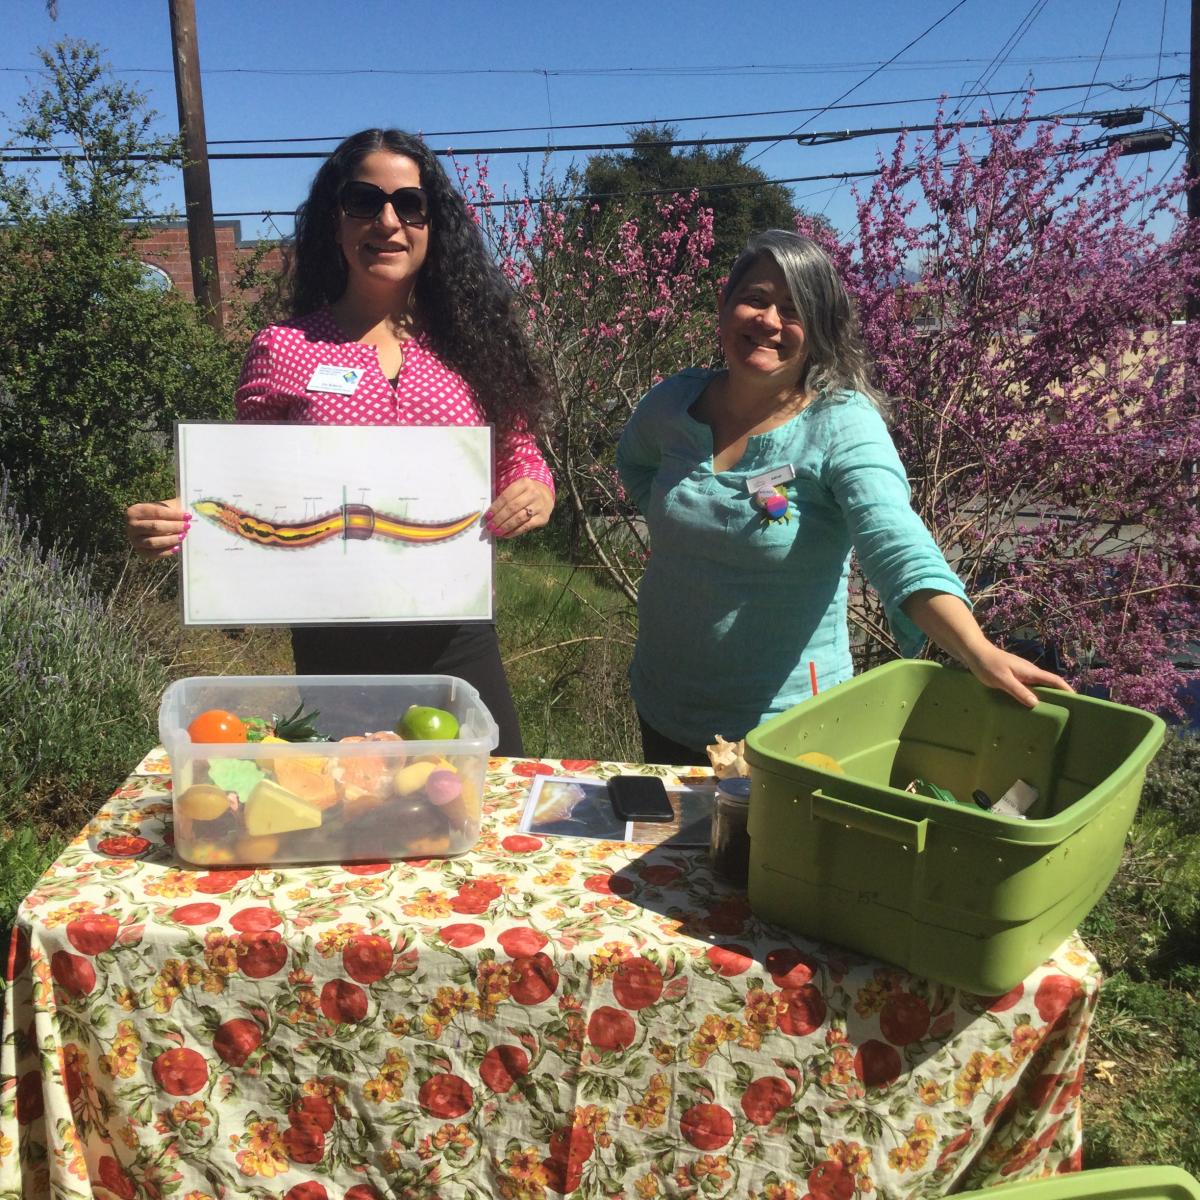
xmin=288 ymin=130 xmax=551 ymax=432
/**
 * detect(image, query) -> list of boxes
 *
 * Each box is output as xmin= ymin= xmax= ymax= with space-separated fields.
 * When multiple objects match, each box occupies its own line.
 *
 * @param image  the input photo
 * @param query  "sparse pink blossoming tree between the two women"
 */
xmin=458 ymin=162 xmax=716 ymax=601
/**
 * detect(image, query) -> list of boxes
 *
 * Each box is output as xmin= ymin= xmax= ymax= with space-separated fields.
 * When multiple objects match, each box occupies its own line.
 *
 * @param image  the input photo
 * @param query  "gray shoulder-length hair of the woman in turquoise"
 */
xmin=721 ymin=229 xmax=890 ymax=416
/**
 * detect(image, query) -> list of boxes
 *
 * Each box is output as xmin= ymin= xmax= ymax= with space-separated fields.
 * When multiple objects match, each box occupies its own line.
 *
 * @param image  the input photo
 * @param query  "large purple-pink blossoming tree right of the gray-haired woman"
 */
xmin=798 ymin=112 xmax=1200 ymax=714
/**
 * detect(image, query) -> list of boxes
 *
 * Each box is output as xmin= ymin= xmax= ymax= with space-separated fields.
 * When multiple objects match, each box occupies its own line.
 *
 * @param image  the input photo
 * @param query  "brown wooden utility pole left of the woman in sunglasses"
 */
xmin=168 ymin=0 xmax=223 ymax=332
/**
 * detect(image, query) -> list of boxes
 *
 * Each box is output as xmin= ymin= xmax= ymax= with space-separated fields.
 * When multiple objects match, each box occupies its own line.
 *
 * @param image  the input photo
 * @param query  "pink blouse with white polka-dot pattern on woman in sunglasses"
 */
xmin=234 ymin=308 xmax=554 ymax=496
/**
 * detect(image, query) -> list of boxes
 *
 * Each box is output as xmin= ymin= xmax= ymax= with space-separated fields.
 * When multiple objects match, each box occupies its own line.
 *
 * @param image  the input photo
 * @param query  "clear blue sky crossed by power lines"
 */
xmin=0 ymin=0 xmax=1189 ymax=243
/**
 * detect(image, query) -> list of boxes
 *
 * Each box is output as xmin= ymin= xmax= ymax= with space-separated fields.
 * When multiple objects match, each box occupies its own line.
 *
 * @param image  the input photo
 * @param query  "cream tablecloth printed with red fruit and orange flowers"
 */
xmin=0 ymin=754 xmax=1099 ymax=1200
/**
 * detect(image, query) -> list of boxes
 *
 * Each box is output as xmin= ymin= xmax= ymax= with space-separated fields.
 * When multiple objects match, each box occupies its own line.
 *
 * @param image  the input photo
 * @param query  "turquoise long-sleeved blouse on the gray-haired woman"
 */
xmin=617 ymin=368 xmax=967 ymax=750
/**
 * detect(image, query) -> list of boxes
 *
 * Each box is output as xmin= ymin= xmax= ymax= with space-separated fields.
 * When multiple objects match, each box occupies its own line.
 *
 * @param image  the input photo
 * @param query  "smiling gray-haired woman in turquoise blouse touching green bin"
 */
xmin=617 ymin=229 xmax=1068 ymax=763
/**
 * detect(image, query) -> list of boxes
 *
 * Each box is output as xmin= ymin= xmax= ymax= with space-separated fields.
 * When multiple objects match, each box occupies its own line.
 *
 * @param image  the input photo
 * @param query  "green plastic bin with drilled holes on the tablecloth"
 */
xmin=746 ymin=660 xmax=1164 ymax=995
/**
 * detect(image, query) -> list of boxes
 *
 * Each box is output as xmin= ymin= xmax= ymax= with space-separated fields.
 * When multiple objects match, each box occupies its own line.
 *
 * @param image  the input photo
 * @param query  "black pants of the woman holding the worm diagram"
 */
xmin=292 ymin=622 xmax=524 ymax=758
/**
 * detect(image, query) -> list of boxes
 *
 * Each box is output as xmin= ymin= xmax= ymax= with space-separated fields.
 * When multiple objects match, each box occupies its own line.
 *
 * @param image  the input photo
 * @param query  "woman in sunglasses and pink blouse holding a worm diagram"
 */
xmin=126 ymin=130 xmax=554 ymax=755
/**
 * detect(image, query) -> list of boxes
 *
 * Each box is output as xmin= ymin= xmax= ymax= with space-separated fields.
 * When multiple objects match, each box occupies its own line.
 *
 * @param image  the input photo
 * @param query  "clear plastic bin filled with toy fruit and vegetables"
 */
xmin=158 ymin=676 xmax=499 ymax=865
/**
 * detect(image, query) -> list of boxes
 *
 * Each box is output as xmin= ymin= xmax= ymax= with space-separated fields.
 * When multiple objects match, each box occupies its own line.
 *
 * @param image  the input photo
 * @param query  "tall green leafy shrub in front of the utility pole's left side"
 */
xmin=0 ymin=41 xmax=240 ymax=571
